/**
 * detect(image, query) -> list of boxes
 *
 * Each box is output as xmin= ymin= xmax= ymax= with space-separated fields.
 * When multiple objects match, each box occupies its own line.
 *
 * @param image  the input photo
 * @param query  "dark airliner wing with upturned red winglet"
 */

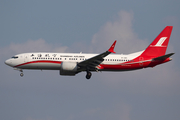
xmin=78 ymin=40 xmax=116 ymax=70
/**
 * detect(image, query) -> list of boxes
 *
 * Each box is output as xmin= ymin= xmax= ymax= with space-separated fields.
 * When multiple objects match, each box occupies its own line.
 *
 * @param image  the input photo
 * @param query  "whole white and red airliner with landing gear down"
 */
xmin=5 ymin=26 xmax=174 ymax=79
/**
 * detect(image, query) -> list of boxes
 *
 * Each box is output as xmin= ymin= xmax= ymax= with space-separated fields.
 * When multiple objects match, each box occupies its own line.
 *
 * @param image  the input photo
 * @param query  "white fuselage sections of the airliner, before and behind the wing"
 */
xmin=5 ymin=51 xmax=143 ymax=70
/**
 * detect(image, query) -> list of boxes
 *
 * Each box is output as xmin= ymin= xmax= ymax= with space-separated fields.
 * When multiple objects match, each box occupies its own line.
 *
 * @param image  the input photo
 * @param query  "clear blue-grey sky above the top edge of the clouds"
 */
xmin=0 ymin=0 xmax=180 ymax=46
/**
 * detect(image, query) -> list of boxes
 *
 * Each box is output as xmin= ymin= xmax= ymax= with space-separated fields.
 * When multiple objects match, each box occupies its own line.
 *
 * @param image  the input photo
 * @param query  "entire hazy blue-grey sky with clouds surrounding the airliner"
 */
xmin=0 ymin=0 xmax=180 ymax=120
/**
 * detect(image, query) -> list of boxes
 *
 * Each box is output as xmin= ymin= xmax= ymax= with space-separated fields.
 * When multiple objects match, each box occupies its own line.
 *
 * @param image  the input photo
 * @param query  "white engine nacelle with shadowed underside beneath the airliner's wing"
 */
xmin=60 ymin=62 xmax=77 ymax=76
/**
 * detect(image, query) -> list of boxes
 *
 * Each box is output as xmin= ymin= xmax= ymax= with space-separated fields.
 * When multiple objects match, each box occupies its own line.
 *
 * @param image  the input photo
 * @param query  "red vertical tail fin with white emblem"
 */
xmin=141 ymin=26 xmax=173 ymax=58
